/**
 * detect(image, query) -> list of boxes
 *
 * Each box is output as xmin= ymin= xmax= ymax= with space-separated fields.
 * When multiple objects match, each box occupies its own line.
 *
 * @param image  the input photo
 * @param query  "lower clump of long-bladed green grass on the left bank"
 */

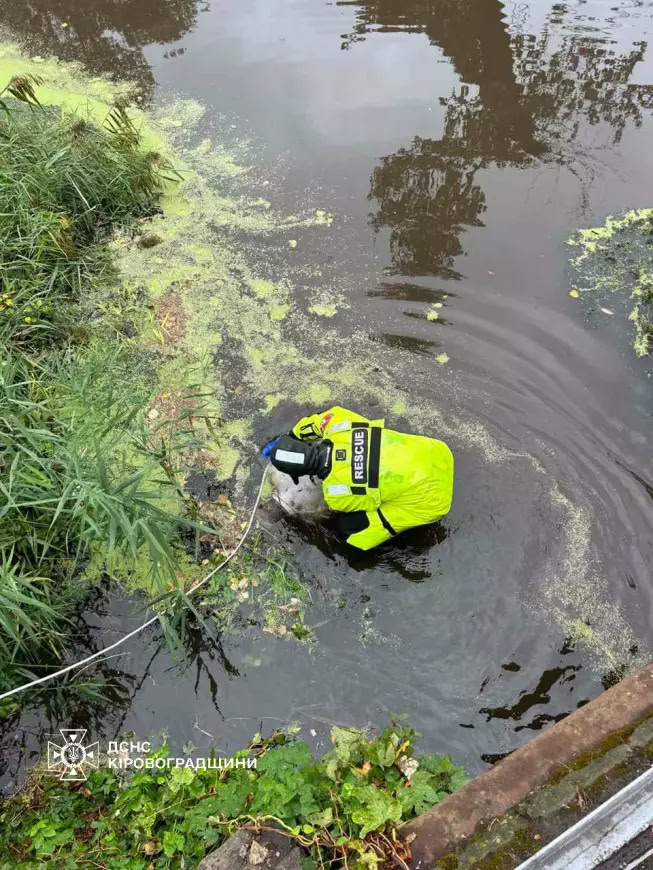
xmin=0 ymin=350 xmax=200 ymax=691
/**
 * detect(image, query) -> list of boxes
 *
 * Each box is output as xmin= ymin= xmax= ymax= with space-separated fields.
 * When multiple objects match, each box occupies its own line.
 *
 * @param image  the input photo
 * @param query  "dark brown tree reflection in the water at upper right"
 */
xmin=339 ymin=0 xmax=653 ymax=278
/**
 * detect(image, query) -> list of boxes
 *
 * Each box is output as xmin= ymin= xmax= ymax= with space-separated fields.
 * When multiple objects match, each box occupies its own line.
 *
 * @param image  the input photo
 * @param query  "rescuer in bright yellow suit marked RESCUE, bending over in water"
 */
xmin=261 ymin=407 xmax=453 ymax=550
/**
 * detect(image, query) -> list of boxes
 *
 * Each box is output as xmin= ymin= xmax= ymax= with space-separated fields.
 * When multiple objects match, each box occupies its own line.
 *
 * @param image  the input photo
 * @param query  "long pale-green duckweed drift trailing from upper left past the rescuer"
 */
xmin=2 ymin=39 xmax=640 ymax=676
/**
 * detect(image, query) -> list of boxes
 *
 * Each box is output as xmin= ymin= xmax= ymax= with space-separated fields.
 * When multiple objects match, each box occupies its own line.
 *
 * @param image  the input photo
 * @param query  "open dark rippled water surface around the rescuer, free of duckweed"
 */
xmin=0 ymin=0 xmax=653 ymax=781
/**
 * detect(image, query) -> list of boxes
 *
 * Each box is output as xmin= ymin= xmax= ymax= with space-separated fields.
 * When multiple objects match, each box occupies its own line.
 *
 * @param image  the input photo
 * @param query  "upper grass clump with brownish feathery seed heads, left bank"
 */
xmin=0 ymin=76 xmax=167 ymax=347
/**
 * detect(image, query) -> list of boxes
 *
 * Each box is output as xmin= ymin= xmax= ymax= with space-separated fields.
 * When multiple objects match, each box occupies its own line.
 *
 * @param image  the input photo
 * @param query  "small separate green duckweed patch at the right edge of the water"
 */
xmin=567 ymin=208 xmax=653 ymax=357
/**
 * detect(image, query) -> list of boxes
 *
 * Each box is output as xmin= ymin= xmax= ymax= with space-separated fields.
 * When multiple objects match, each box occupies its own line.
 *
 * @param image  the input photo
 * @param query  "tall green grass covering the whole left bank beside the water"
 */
xmin=0 ymin=77 xmax=194 ymax=690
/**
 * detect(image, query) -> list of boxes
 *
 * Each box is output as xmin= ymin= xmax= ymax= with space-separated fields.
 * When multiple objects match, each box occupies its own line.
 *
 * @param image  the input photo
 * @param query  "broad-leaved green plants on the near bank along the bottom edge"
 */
xmin=0 ymin=722 xmax=465 ymax=870
